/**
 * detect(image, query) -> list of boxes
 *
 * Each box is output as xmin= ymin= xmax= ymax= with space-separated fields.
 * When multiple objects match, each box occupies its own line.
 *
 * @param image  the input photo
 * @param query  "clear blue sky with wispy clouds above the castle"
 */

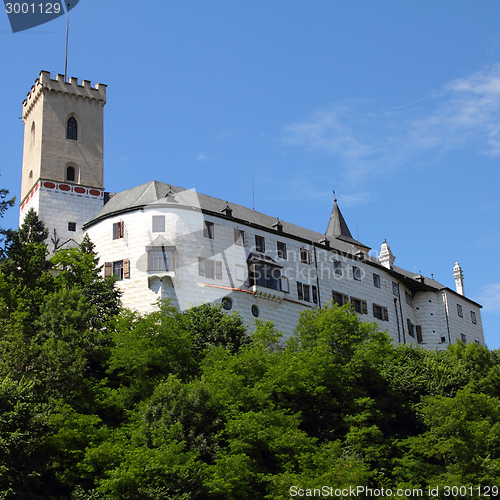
xmin=0 ymin=0 xmax=500 ymax=348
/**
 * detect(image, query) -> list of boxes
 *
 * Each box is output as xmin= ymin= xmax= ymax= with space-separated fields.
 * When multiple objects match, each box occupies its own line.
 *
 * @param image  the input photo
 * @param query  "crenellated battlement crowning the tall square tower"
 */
xmin=23 ymin=71 xmax=107 ymax=120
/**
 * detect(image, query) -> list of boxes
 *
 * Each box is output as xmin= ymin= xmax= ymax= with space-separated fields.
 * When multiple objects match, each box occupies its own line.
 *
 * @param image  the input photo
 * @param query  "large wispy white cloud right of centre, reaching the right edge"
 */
xmin=282 ymin=64 xmax=500 ymax=184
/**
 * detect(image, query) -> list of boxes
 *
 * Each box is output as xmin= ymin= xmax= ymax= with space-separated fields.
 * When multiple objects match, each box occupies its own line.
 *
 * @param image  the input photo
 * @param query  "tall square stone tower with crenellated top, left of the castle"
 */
xmin=20 ymin=71 xmax=106 ymax=251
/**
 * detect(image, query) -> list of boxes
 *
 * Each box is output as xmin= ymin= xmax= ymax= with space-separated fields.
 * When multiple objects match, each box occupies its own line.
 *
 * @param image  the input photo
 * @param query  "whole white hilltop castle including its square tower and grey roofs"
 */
xmin=20 ymin=71 xmax=484 ymax=349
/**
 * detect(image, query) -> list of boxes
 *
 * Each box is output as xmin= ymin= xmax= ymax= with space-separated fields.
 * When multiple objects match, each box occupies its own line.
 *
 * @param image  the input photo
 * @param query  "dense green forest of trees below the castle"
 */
xmin=0 ymin=201 xmax=500 ymax=500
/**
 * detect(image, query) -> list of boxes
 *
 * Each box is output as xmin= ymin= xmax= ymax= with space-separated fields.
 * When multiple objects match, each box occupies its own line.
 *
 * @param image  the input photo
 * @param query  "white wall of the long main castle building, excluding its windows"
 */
xmin=88 ymin=201 xmax=484 ymax=349
